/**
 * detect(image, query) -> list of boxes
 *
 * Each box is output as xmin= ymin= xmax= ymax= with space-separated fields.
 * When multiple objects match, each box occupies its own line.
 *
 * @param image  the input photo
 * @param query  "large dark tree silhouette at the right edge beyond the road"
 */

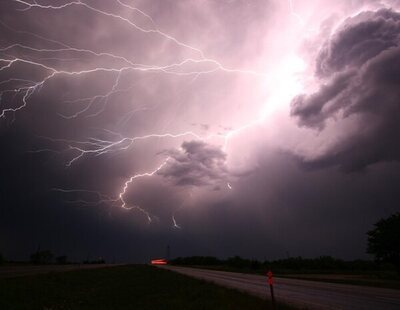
xmin=367 ymin=212 xmax=400 ymax=273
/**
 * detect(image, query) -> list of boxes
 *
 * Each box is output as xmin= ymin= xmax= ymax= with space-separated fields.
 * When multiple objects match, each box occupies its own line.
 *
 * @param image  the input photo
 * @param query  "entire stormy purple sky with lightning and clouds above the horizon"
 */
xmin=0 ymin=0 xmax=400 ymax=262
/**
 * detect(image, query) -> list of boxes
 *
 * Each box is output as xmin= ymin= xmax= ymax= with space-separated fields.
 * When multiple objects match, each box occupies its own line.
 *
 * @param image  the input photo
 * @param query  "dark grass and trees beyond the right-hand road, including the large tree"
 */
xmin=171 ymin=212 xmax=400 ymax=289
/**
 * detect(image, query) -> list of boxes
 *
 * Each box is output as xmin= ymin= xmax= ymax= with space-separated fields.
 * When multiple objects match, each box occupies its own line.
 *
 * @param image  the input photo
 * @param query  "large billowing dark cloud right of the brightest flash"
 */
xmin=291 ymin=9 xmax=400 ymax=170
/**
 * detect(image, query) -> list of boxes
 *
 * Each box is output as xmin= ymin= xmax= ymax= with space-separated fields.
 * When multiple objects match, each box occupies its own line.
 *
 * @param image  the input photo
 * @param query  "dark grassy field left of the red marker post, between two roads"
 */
xmin=0 ymin=265 xmax=292 ymax=310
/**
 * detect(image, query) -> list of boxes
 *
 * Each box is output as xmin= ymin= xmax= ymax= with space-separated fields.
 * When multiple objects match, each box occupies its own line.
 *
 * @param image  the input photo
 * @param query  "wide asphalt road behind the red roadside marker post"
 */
xmin=161 ymin=266 xmax=400 ymax=310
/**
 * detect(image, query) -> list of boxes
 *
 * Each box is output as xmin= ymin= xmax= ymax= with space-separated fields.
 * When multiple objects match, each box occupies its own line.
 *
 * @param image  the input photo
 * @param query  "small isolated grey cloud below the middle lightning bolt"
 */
xmin=158 ymin=141 xmax=228 ymax=188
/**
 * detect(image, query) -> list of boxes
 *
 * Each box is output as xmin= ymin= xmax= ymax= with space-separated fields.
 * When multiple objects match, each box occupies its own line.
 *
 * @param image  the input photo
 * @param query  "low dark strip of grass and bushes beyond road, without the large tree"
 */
xmin=170 ymin=256 xmax=400 ymax=289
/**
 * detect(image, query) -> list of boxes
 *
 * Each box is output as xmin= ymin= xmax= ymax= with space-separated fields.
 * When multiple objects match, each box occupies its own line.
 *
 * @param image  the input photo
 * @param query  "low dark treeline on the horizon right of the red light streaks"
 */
xmin=170 ymin=256 xmax=391 ymax=272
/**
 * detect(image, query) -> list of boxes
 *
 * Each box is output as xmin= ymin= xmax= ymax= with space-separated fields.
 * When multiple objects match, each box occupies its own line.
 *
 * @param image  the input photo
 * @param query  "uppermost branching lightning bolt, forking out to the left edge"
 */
xmin=0 ymin=0 xmax=265 ymax=119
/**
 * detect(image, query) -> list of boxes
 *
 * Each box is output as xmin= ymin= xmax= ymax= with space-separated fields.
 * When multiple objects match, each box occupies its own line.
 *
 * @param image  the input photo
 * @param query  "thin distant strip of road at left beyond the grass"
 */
xmin=0 ymin=264 xmax=116 ymax=279
